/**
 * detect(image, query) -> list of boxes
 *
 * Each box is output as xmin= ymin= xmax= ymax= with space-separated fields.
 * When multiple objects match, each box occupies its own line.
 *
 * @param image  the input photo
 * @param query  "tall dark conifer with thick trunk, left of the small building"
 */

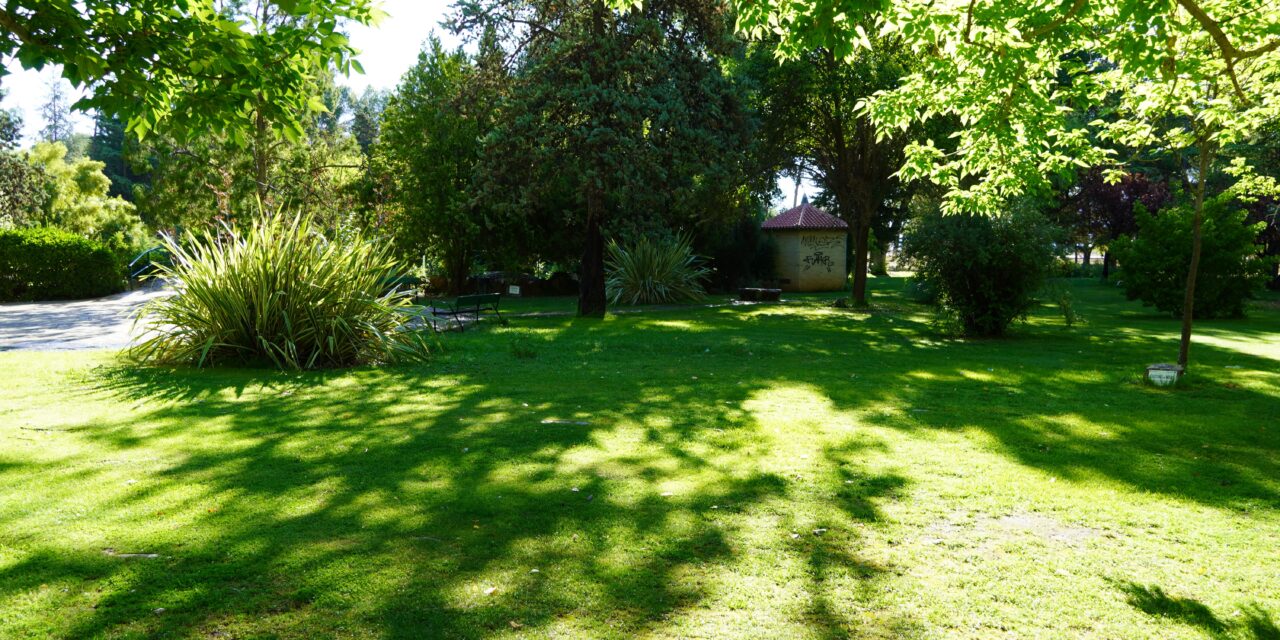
xmin=453 ymin=0 xmax=740 ymax=317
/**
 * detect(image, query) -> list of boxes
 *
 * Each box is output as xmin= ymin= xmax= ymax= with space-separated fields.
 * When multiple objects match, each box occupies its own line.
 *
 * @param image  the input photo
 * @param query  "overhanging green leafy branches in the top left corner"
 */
xmin=0 ymin=0 xmax=381 ymax=146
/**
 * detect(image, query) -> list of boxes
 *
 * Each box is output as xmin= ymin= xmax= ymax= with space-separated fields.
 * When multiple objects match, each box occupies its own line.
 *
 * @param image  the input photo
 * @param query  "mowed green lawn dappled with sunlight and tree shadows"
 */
xmin=0 ymin=279 xmax=1280 ymax=639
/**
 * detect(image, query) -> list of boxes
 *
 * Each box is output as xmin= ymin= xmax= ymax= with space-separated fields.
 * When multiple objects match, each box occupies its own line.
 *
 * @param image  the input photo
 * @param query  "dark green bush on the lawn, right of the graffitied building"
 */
xmin=904 ymin=211 xmax=1055 ymax=335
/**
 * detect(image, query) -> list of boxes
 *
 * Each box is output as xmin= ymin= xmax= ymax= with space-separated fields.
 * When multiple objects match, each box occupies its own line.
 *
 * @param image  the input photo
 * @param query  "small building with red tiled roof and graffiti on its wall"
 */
xmin=762 ymin=198 xmax=849 ymax=291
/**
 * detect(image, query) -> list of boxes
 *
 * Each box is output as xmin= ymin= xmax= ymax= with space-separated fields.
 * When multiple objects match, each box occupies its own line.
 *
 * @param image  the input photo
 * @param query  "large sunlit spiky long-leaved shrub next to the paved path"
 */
xmin=131 ymin=212 xmax=428 ymax=369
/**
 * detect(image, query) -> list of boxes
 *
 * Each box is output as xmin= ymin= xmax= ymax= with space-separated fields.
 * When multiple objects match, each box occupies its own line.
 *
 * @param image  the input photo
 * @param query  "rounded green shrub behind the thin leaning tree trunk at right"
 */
xmin=1115 ymin=196 xmax=1274 ymax=317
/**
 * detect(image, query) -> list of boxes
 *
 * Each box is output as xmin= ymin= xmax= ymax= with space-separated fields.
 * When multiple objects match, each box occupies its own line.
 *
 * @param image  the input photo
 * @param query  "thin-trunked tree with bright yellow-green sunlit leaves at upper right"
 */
xmin=733 ymin=0 xmax=1280 ymax=367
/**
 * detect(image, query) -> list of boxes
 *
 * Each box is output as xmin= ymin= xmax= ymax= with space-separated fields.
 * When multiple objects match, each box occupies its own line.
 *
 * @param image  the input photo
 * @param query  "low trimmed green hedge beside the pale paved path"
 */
xmin=0 ymin=227 xmax=124 ymax=302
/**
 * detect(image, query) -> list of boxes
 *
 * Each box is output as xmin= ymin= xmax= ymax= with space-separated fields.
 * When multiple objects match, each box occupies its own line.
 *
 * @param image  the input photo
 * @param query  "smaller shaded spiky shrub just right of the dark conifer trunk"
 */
xmin=604 ymin=236 xmax=712 ymax=305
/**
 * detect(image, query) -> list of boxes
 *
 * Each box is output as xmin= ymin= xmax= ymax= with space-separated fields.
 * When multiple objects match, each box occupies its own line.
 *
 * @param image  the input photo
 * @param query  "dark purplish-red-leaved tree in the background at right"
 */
xmin=1061 ymin=168 xmax=1172 ymax=280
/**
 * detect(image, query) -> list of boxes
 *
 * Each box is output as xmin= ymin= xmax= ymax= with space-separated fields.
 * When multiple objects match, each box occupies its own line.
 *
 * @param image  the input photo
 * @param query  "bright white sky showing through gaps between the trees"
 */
xmin=0 ymin=0 xmax=813 ymax=206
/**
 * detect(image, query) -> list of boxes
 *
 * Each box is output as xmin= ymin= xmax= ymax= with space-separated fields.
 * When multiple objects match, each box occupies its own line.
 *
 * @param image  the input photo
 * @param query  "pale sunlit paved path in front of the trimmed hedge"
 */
xmin=0 ymin=287 xmax=168 ymax=351
